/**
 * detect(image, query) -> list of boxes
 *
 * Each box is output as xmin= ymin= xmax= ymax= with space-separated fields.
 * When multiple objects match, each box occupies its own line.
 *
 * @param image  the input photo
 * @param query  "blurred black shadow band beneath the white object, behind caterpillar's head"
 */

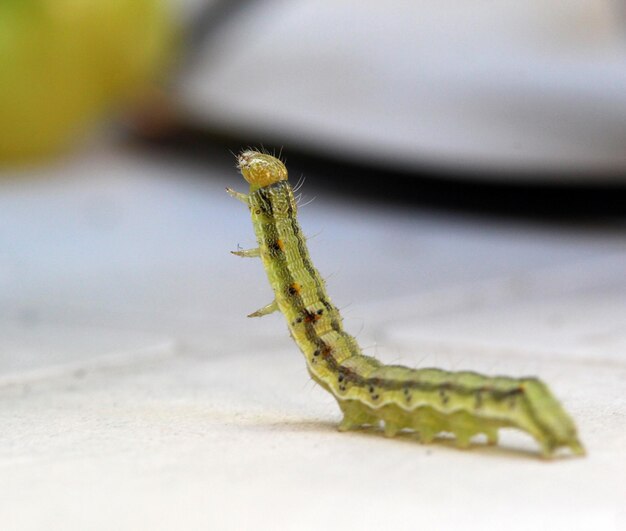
xmin=134 ymin=123 xmax=626 ymax=219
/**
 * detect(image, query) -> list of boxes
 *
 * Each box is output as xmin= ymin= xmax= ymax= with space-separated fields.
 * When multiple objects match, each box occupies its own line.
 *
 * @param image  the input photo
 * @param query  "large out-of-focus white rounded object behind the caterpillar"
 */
xmin=178 ymin=0 xmax=626 ymax=180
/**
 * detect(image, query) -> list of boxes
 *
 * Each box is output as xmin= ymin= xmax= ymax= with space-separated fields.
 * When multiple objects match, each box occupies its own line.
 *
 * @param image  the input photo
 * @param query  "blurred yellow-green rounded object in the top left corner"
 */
xmin=0 ymin=0 xmax=175 ymax=163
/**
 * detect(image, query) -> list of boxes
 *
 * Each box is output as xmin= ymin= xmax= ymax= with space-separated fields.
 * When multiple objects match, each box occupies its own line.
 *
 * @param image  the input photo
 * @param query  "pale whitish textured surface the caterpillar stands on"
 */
xmin=0 ymin=147 xmax=626 ymax=530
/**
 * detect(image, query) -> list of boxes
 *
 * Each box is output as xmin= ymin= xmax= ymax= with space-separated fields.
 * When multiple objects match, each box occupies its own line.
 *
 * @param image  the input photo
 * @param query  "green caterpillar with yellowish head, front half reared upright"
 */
xmin=226 ymin=150 xmax=585 ymax=457
